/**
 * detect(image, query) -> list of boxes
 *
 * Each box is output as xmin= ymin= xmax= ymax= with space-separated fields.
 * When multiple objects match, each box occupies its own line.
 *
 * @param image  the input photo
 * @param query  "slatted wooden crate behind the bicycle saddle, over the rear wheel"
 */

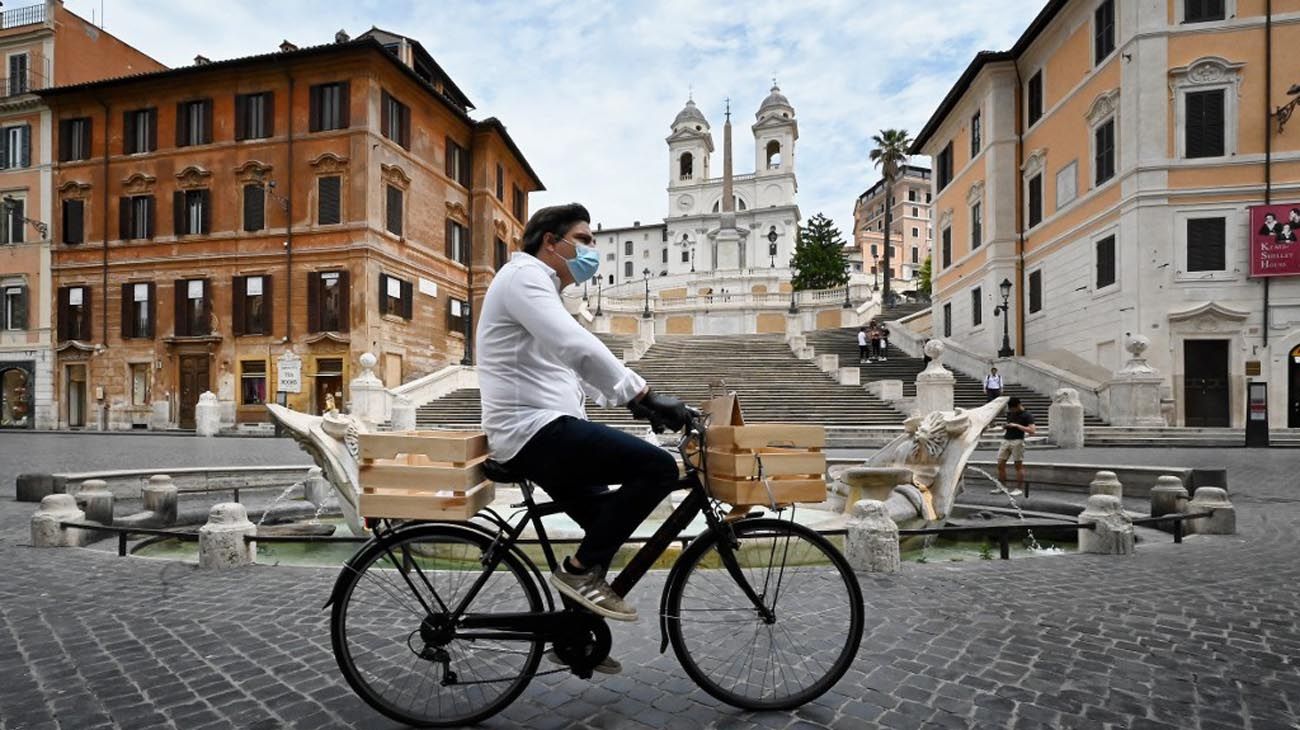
xmin=358 ymin=431 xmax=497 ymax=521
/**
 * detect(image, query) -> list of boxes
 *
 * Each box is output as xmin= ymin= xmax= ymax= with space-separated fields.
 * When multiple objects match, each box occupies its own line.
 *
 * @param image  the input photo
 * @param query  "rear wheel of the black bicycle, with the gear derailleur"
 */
xmin=330 ymin=525 xmax=543 ymax=727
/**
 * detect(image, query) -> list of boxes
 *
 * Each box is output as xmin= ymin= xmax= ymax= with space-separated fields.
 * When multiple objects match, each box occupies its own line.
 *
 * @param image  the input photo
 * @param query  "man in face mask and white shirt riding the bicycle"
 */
xmin=477 ymin=203 xmax=690 ymax=631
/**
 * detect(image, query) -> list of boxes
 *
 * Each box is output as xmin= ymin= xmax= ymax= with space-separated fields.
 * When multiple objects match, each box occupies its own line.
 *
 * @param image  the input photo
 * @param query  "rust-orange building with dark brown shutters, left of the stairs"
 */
xmin=42 ymin=29 xmax=541 ymax=429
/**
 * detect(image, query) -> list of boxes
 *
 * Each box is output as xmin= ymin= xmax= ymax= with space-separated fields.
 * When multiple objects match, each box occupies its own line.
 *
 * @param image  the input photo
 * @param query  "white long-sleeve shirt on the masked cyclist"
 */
xmin=476 ymin=252 xmax=646 ymax=461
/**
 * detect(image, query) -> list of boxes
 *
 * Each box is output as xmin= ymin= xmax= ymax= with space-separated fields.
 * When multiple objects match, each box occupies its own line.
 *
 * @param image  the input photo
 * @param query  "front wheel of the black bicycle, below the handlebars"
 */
xmin=666 ymin=520 xmax=863 ymax=711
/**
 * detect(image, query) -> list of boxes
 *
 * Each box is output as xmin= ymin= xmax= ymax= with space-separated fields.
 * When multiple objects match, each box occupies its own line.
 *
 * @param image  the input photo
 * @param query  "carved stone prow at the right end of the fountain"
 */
xmin=835 ymin=340 xmax=1009 ymax=529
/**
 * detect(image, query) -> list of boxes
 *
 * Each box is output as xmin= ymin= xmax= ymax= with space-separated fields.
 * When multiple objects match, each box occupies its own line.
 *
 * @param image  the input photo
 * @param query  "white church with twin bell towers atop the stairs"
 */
xmin=594 ymin=81 xmax=800 ymax=288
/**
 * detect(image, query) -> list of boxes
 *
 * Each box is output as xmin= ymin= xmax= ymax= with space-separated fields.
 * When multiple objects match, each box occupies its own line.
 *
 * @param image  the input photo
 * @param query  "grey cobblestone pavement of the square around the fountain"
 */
xmin=0 ymin=434 xmax=1300 ymax=730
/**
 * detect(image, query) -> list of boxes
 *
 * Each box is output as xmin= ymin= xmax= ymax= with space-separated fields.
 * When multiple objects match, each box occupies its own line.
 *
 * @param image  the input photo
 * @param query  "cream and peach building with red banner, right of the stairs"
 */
xmin=913 ymin=0 xmax=1300 ymax=427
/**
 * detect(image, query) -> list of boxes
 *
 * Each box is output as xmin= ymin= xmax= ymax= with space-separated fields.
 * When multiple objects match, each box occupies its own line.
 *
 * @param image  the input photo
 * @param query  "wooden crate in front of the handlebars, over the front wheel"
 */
xmin=707 ymin=423 xmax=826 ymax=507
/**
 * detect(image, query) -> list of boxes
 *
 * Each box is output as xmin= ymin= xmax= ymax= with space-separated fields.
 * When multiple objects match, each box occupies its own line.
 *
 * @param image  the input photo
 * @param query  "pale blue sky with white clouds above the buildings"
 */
xmin=65 ymin=0 xmax=1044 ymax=231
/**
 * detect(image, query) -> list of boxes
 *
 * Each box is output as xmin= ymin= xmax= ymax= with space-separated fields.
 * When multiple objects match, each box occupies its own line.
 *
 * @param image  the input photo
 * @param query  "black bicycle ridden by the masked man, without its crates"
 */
xmin=326 ymin=418 xmax=863 ymax=727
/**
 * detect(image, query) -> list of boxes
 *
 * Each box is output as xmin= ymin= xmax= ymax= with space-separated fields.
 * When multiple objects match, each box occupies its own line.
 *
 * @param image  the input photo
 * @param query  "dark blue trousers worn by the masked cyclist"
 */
xmin=507 ymin=416 xmax=677 ymax=568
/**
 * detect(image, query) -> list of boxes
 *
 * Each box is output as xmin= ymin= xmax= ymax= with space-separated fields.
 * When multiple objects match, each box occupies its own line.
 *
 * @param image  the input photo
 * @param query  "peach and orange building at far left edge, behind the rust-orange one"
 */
xmin=0 ymin=0 xmax=164 ymax=429
